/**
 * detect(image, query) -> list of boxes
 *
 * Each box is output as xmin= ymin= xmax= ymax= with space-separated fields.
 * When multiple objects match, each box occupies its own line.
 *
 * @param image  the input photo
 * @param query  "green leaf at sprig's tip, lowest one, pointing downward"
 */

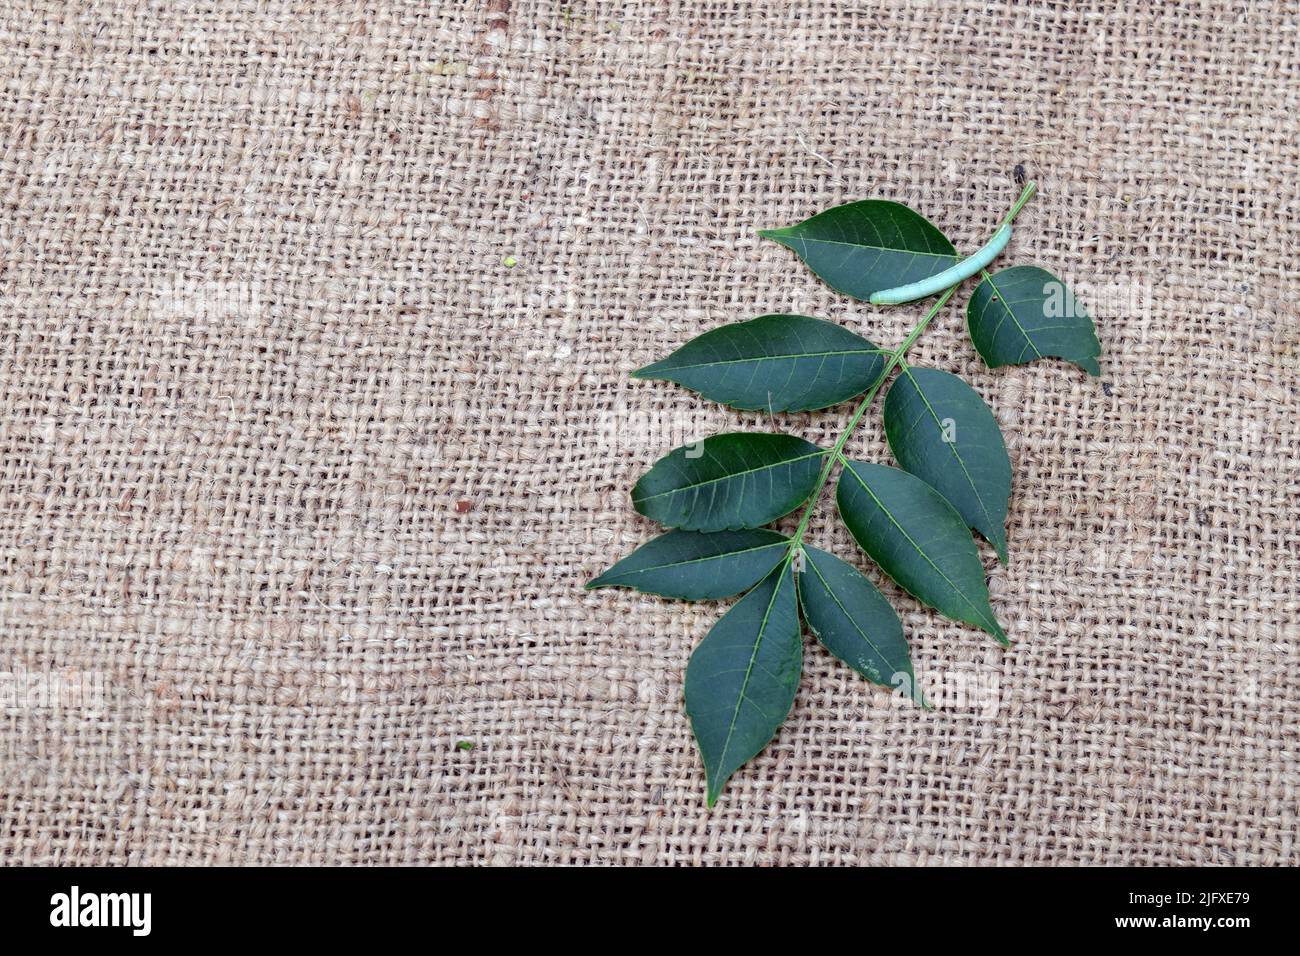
xmin=685 ymin=562 xmax=803 ymax=806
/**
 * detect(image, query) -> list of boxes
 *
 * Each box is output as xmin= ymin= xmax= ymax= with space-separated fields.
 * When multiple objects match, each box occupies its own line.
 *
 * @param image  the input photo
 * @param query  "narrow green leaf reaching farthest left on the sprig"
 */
xmin=586 ymin=529 xmax=790 ymax=601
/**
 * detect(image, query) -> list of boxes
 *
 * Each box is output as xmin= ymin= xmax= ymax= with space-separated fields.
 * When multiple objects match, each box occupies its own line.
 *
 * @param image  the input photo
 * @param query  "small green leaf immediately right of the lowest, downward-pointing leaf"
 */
xmin=800 ymin=545 xmax=922 ymax=704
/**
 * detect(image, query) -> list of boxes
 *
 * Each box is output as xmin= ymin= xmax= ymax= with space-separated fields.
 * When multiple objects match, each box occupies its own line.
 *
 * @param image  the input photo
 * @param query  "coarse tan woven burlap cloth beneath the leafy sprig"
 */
xmin=0 ymin=0 xmax=1300 ymax=865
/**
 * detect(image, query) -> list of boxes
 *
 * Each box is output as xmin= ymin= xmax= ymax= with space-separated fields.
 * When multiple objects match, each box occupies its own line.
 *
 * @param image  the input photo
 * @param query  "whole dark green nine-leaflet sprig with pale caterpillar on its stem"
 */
xmin=588 ymin=182 xmax=1101 ymax=806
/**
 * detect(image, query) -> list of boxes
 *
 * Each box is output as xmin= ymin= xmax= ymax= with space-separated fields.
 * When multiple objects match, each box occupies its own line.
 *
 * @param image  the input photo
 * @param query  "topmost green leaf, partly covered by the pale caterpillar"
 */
xmin=759 ymin=199 xmax=959 ymax=299
